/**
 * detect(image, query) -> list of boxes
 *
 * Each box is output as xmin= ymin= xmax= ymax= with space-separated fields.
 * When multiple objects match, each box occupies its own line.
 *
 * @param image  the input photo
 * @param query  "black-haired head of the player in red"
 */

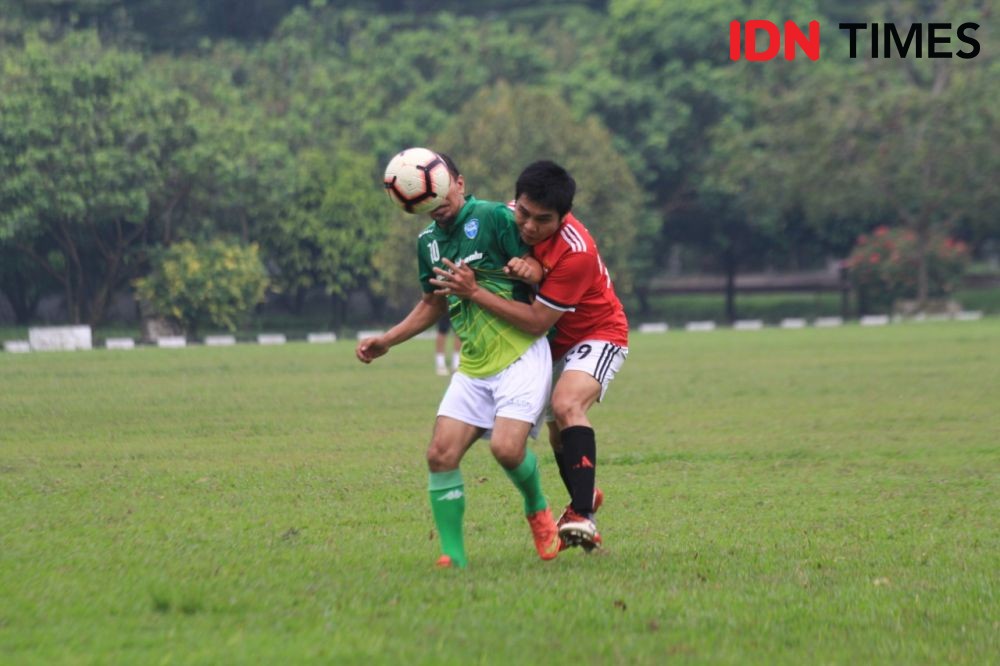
xmin=514 ymin=160 xmax=576 ymax=245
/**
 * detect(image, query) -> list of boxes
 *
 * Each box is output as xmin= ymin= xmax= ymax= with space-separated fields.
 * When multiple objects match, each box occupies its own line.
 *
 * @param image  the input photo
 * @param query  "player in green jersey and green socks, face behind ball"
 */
xmin=355 ymin=154 xmax=561 ymax=567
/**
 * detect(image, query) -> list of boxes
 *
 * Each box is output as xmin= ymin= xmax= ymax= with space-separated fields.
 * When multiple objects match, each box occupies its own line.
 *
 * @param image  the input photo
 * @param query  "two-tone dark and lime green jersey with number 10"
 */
xmin=417 ymin=197 xmax=535 ymax=377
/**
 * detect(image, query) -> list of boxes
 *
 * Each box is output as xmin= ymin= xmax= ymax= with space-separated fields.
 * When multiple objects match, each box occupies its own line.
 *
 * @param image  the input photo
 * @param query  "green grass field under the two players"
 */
xmin=0 ymin=319 xmax=1000 ymax=664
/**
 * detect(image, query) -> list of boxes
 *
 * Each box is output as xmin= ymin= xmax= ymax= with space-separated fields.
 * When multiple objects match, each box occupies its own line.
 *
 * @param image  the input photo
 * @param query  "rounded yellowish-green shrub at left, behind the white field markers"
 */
xmin=135 ymin=240 xmax=268 ymax=335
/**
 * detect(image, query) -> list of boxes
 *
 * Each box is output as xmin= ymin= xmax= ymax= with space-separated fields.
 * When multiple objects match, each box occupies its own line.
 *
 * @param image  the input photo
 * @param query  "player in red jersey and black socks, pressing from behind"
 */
xmin=431 ymin=161 xmax=628 ymax=551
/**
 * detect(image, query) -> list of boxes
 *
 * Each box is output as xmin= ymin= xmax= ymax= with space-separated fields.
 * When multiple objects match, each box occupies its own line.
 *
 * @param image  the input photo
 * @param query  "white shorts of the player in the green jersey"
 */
xmin=438 ymin=338 xmax=552 ymax=439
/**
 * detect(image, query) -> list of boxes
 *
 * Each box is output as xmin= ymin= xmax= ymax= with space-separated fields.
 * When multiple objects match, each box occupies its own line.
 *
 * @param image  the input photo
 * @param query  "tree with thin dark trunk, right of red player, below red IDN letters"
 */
xmin=692 ymin=15 xmax=853 ymax=322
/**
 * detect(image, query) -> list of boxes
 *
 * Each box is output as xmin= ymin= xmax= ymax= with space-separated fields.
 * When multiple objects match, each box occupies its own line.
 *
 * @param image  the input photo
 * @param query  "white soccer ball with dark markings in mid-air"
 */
xmin=385 ymin=148 xmax=451 ymax=214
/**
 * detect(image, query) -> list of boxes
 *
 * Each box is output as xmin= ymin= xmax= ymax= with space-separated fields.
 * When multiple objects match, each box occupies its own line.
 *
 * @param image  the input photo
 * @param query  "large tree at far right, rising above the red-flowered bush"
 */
xmin=724 ymin=2 xmax=1000 ymax=306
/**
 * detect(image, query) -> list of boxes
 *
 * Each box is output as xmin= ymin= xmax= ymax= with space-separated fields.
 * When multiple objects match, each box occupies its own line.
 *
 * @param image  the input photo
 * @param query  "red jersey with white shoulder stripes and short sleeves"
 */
xmin=531 ymin=214 xmax=628 ymax=360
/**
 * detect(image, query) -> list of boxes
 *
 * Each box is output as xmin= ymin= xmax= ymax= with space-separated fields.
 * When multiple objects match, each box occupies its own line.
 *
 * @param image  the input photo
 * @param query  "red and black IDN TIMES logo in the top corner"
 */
xmin=729 ymin=20 xmax=982 ymax=62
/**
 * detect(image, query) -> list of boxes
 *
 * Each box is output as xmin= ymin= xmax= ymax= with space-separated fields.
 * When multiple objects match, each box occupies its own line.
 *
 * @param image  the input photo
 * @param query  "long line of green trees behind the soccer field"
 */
xmin=0 ymin=0 xmax=1000 ymax=324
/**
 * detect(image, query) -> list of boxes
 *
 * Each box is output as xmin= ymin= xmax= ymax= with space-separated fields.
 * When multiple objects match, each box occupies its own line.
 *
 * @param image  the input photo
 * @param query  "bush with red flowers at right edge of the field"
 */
xmin=846 ymin=226 xmax=969 ymax=306
